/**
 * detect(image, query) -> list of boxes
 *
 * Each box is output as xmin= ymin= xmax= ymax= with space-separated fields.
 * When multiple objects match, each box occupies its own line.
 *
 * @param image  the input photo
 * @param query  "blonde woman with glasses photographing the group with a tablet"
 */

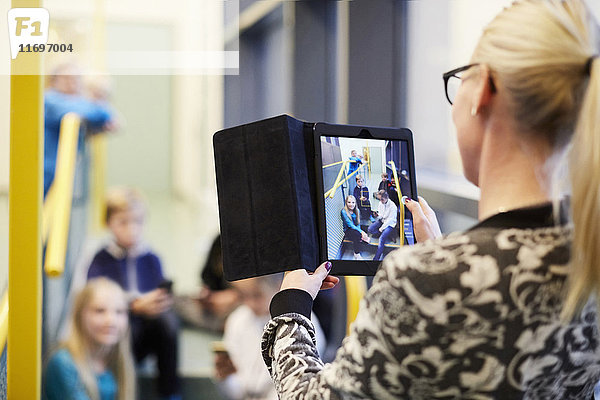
xmin=262 ymin=0 xmax=600 ymax=400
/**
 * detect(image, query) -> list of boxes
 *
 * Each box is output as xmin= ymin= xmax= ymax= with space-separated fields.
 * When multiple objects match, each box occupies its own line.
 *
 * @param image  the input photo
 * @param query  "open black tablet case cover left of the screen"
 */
xmin=213 ymin=115 xmax=319 ymax=281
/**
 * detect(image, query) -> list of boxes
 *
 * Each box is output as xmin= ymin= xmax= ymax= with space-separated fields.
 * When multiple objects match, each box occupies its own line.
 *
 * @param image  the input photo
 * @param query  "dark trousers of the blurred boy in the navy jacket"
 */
xmin=130 ymin=310 xmax=180 ymax=396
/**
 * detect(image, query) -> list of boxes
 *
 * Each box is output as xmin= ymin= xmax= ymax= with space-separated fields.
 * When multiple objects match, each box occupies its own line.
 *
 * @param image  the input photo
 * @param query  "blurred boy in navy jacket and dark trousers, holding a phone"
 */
xmin=88 ymin=188 xmax=180 ymax=399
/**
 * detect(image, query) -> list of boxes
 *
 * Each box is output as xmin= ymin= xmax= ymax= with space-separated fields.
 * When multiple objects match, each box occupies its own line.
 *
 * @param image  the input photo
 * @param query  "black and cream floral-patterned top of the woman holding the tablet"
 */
xmin=262 ymin=205 xmax=600 ymax=400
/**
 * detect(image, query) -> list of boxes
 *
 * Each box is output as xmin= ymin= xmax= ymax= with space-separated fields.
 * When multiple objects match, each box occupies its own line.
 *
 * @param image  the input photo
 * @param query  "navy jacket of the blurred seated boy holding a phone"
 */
xmin=87 ymin=244 xmax=164 ymax=294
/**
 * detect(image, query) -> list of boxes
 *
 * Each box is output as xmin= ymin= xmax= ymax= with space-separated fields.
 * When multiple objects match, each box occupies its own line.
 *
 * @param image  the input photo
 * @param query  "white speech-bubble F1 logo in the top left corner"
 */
xmin=8 ymin=8 xmax=50 ymax=60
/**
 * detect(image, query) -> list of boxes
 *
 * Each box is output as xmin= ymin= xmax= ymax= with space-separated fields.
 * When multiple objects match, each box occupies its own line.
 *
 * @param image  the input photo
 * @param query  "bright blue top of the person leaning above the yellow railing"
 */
xmin=44 ymin=89 xmax=112 ymax=196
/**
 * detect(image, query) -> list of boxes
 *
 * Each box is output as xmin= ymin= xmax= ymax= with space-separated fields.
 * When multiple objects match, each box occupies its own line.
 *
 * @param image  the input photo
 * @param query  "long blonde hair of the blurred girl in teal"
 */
xmin=62 ymin=278 xmax=135 ymax=400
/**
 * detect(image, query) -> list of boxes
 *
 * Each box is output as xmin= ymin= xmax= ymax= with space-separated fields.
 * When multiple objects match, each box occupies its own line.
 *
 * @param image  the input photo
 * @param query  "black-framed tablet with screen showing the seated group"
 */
xmin=313 ymin=123 xmax=417 ymax=275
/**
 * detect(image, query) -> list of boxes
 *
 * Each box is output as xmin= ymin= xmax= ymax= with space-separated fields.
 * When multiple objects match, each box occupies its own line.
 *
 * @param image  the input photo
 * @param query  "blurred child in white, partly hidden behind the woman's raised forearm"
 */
xmin=215 ymin=274 xmax=325 ymax=400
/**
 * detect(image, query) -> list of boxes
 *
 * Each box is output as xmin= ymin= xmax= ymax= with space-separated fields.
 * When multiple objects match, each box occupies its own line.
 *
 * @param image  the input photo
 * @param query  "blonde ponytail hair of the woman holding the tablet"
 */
xmin=472 ymin=0 xmax=600 ymax=319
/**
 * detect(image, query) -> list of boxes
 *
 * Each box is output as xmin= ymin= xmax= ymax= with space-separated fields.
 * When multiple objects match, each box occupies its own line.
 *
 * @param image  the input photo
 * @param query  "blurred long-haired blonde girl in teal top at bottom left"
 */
xmin=42 ymin=278 xmax=135 ymax=400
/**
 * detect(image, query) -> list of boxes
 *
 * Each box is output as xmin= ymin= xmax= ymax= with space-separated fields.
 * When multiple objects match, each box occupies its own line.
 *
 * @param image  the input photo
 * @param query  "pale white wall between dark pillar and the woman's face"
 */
xmin=407 ymin=0 xmax=600 ymax=196
